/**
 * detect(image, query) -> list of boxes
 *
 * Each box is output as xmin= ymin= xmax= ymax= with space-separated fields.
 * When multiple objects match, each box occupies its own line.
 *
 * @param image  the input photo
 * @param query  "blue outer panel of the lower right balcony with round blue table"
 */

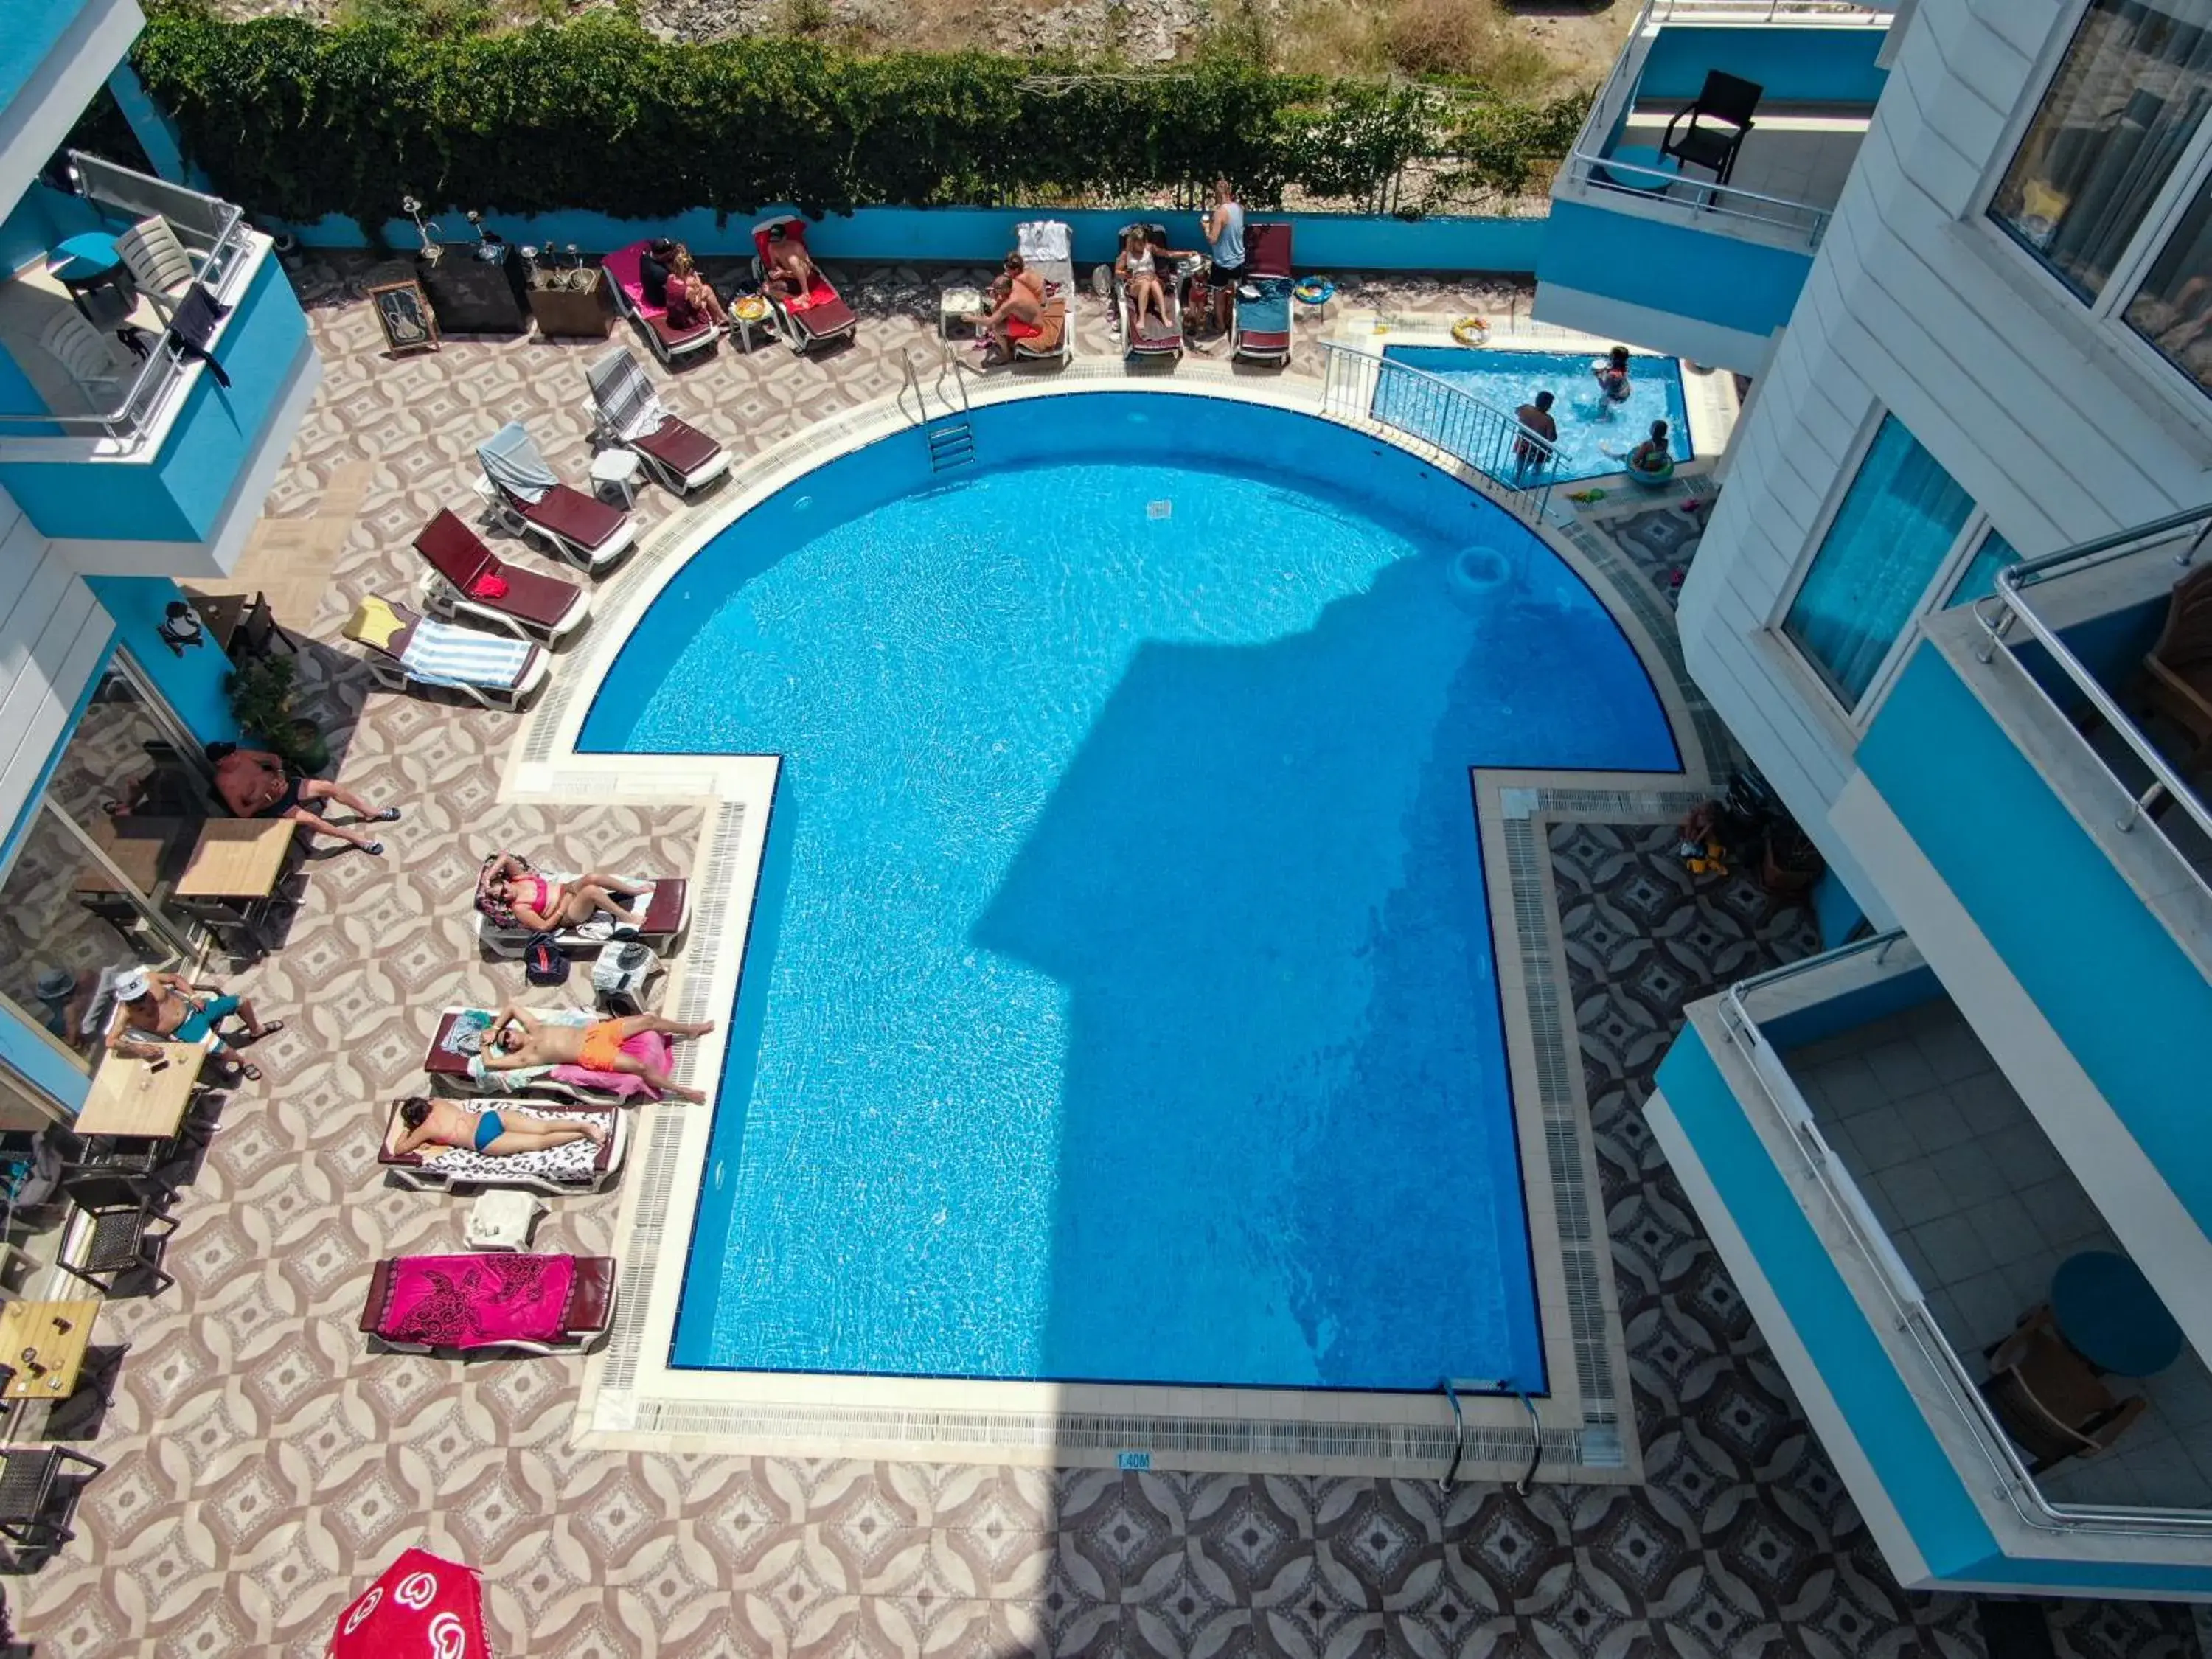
xmin=1659 ymin=1029 xmax=2212 ymax=1595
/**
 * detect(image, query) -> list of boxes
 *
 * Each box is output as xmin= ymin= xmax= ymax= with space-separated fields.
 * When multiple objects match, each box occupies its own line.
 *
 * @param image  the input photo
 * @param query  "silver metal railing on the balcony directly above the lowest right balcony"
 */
xmin=1973 ymin=504 xmax=2212 ymax=891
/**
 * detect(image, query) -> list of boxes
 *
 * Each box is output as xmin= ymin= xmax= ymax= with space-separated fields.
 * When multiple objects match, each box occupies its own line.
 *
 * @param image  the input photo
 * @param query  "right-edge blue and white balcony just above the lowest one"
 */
xmin=1858 ymin=509 xmax=2212 ymax=1283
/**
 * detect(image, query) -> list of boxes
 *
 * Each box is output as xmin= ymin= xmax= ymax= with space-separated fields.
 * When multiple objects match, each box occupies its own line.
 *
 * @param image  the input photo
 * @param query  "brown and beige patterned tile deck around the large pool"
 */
xmin=4 ymin=253 xmax=2197 ymax=1659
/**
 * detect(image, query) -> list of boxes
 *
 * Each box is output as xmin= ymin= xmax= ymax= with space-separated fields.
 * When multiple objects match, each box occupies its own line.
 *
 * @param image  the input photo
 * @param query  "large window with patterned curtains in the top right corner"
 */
xmin=1989 ymin=0 xmax=2212 ymax=403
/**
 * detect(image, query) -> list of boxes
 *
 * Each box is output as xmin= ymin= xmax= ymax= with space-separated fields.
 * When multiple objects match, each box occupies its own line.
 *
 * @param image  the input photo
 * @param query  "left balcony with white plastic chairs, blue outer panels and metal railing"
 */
xmin=0 ymin=155 xmax=319 ymax=575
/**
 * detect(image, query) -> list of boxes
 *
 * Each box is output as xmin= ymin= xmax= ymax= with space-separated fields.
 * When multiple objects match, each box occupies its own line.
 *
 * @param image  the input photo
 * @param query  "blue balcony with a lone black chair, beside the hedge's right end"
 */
xmin=1535 ymin=0 xmax=1889 ymax=374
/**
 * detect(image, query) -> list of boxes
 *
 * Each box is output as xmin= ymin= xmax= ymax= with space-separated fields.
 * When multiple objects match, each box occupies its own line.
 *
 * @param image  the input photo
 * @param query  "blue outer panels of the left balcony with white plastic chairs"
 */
xmin=0 ymin=259 xmax=307 ymax=542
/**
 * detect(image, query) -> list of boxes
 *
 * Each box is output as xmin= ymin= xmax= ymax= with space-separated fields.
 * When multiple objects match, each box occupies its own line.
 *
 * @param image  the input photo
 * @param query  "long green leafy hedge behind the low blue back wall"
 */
xmin=133 ymin=9 xmax=1586 ymax=228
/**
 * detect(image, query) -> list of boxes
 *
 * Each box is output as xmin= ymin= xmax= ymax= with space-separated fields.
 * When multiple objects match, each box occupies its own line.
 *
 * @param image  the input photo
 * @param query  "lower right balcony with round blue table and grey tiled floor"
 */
xmin=1646 ymin=933 xmax=2212 ymax=1595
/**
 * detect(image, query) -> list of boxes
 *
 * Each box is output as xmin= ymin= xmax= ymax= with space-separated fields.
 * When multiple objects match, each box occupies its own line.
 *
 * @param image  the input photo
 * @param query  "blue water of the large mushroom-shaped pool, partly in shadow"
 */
xmin=584 ymin=394 xmax=1677 ymax=1389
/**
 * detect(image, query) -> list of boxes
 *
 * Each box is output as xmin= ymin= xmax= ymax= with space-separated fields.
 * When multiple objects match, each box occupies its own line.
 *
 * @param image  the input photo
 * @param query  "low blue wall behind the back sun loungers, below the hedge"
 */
xmin=268 ymin=208 xmax=1546 ymax=272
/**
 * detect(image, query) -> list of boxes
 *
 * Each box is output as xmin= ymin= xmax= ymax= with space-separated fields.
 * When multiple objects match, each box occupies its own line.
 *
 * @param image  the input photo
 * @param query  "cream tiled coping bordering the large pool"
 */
xmin=500 ymin=336 xmax=1710 ymax=1482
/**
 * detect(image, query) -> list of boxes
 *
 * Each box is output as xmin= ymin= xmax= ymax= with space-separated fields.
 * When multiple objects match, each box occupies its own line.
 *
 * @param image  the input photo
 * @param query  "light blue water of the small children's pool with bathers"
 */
xmin=1376 ymin=345 xmax=1692 ymax=484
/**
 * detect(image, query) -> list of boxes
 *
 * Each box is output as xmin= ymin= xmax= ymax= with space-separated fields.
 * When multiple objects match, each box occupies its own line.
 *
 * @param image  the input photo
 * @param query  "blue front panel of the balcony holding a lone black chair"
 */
xmin=1535 ymin=201 xmax=1812 ymax=334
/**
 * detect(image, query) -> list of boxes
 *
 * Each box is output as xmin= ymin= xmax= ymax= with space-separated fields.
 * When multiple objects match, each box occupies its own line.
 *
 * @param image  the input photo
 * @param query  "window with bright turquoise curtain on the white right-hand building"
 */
xmin=1783 ymin=416 xmax=1973 ymax=710
